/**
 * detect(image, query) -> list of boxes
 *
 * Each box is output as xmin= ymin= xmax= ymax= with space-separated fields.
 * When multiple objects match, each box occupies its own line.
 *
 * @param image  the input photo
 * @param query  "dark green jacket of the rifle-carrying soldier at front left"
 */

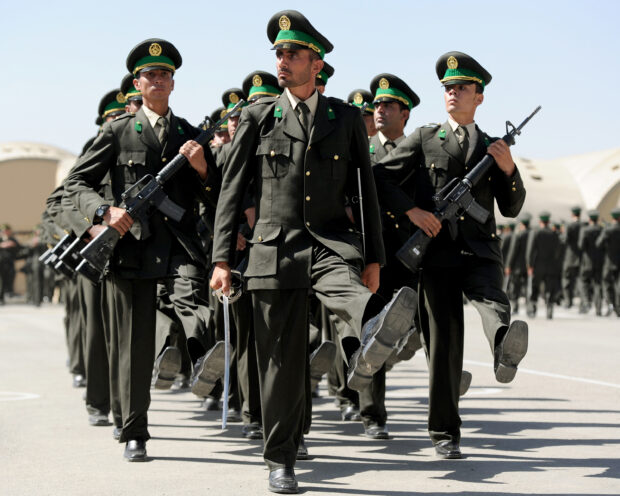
xmin=65 ymin=109 xmax=220 ymax=278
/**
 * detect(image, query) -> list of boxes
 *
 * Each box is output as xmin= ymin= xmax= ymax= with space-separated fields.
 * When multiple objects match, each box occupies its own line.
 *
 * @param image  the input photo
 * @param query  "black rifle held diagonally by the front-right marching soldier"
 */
xmin=396 ymin=106 xmax=541 ymax=271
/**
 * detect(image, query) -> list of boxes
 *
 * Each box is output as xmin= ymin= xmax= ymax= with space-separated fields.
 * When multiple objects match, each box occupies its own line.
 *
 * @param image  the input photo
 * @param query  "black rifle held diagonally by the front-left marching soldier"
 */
xmin=77 ymin=100 xmax=244 ymax=280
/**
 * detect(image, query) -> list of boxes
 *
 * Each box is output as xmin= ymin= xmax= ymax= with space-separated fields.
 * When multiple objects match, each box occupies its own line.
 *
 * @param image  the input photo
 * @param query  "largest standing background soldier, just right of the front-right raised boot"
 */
xmin=525 ymin=211 xmax=560 ymax=319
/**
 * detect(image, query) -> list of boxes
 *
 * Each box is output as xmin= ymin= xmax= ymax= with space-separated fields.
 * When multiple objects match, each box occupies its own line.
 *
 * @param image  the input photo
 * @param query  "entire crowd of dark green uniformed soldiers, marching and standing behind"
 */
xmin=0 ymin=10 xmax=620 ymax=493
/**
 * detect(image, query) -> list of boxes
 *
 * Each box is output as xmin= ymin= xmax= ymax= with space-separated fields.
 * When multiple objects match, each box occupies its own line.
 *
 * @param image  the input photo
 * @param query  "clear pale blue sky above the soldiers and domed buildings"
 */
xmin=0 ymin=0 xmax=620 ymax=159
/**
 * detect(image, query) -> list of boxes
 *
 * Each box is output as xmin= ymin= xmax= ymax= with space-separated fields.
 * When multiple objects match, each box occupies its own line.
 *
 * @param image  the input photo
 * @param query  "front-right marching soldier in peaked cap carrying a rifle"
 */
xmin=374 ymin=52 xmax=527 ymax=458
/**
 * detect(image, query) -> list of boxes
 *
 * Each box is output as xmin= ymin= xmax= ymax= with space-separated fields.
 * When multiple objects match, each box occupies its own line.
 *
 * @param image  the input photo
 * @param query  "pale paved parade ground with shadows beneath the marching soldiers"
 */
xmin=0 ymin=304 xmax=620 ymax=496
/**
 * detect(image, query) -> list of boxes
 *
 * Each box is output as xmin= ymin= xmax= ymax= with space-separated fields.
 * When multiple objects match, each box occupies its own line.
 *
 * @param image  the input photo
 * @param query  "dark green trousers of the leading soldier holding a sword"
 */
xmin=251 ymin=243 xmax=372 ymax=470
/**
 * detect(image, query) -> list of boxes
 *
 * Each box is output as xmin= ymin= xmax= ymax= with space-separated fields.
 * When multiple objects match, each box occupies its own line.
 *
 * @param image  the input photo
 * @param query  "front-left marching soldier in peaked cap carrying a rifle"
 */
xmin=66 ymin=39 xmax=224 ymax=461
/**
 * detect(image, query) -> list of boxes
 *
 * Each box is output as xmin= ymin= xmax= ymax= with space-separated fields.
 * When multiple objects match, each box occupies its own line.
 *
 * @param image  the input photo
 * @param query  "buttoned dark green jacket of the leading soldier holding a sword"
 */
xmin=213 ymin=95 xmax=385 ymax=289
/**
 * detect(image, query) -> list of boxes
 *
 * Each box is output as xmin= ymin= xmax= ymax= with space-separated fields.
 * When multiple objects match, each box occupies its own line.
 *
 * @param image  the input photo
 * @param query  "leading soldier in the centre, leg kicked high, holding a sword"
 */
xmin=211 ymin=10 xmax=415 ymax=493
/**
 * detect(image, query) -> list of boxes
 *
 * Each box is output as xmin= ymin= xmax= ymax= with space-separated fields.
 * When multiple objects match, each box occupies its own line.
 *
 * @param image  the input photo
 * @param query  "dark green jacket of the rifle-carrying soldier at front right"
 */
xmin=373 ymin=122 xmax=525 ymax=266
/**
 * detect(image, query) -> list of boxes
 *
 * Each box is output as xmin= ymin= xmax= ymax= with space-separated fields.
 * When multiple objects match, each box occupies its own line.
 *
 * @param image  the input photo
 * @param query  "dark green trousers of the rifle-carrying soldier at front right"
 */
xmin=420 ymin=255 xmax=510 ymax=444
